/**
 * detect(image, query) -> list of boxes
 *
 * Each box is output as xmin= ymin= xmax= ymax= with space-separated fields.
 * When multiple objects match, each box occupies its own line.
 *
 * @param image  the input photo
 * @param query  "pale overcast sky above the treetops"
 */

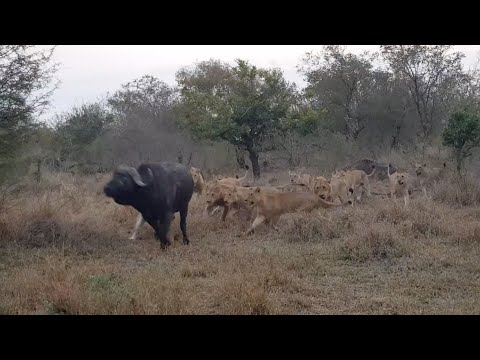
xmin=40 ymin=45 xmax=480 ymax=117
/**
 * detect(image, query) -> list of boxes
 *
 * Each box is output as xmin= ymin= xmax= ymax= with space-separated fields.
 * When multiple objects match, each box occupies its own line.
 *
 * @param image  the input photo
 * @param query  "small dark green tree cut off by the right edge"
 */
xmin=442 ymin=112 xmax=480 ymax=173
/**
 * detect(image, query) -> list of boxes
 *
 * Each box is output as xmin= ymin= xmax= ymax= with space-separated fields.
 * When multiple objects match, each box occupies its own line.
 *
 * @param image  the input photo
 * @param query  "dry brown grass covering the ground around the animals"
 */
xmin=0 ymin=174 xmax=480 ymax=314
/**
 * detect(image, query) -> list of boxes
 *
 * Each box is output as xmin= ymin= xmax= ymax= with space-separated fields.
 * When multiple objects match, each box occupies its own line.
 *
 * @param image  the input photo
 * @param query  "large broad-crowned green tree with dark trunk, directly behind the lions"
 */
xmin=177 ymin=59 xmax=295 ymax=178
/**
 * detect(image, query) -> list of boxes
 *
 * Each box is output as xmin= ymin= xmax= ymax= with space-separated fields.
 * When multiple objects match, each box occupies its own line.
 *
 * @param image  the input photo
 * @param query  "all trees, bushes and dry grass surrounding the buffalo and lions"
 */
xmin=0 ymin=45 xmax=480 ymax=314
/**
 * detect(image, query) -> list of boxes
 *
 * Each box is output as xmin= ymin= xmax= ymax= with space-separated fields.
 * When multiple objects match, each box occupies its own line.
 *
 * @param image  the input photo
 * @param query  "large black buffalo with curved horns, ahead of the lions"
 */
xmin=104 ymin=162 xmax=193 ymax=248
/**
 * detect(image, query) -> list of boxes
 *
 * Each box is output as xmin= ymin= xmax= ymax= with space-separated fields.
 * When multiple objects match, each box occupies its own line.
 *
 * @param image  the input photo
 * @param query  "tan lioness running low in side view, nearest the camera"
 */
xmin=245 ymin=187 xmax=341 ymax=235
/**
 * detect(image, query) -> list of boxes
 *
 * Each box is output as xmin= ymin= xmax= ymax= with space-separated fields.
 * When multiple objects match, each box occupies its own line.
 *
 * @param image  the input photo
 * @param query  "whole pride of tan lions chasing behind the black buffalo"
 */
xmin=130 ymin=159 xmax=446 ymax=239
